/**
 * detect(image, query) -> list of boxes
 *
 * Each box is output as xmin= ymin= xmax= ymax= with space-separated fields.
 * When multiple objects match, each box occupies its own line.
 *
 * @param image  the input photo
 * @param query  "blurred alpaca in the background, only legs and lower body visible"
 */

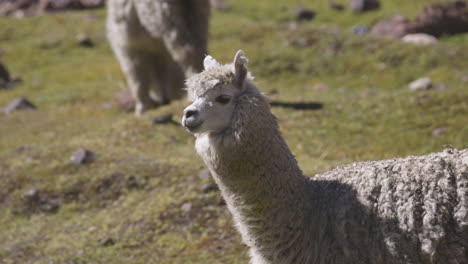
xmin=106 ymin=0 xmax=210 ymax=116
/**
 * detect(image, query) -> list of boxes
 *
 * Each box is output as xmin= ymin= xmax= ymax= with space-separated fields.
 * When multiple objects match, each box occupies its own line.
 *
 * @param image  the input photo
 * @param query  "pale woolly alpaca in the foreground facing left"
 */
xmin=182 ymin=51 xmax=468 ymax=264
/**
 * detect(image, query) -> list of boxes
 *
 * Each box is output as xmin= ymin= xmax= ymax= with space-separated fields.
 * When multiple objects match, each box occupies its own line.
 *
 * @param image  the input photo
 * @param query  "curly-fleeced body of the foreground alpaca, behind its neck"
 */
xmin=313 ymin=150 xmax=468 ymax=263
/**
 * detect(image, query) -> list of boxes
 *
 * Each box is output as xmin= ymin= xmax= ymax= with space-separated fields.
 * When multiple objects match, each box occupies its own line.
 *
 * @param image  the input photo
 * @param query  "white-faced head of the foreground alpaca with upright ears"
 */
xmin=182 ymin=50 xmax=256 ymax=134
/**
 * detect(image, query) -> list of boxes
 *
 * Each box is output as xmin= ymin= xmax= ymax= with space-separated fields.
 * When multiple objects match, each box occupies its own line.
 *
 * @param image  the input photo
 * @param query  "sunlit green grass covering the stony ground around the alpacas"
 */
xmin=0 ymin=0 xmax=468 ymax=264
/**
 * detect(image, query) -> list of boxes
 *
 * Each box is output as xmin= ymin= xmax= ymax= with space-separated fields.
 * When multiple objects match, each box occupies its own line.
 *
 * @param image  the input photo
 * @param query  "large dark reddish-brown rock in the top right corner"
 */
xmin=409 ymin=0 xmax=468 ymax=37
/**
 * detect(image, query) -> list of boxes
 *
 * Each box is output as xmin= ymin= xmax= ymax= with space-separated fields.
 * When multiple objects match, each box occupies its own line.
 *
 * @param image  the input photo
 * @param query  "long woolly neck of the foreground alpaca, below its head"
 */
xmin=197 ymin=94 xmax=309 ymax=254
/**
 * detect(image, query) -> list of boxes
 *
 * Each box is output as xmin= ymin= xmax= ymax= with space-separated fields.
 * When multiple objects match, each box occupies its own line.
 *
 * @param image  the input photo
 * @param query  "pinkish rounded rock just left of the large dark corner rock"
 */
xmin=371 ymin=15 xmax=410 ymax=38
